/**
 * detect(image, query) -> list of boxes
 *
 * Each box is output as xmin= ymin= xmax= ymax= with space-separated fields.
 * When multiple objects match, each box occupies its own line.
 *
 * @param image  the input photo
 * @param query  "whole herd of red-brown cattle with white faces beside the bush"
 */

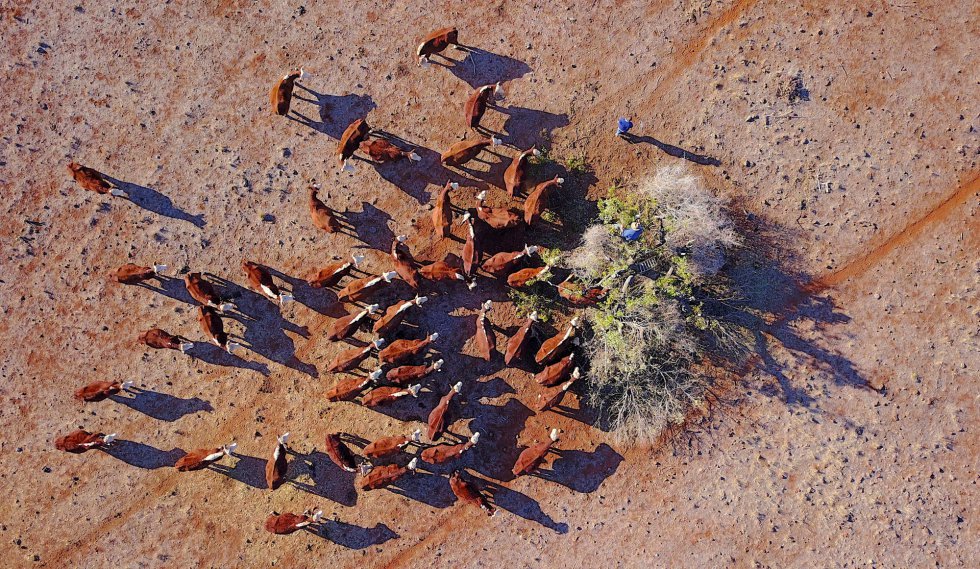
xmin=61 ymin=28 xmax=604 ymax=534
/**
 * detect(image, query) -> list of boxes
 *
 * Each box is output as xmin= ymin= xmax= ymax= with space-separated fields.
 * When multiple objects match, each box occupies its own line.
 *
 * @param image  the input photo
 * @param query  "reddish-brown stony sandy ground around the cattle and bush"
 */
xmin=0 ymin=0 xmax=980 ymax=567
